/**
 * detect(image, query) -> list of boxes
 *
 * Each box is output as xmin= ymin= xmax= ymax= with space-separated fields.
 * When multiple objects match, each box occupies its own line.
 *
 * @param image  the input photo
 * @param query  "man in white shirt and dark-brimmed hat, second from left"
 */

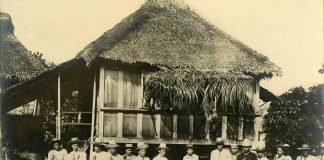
xmin=67 ymin=137 xmax=87 ymax=160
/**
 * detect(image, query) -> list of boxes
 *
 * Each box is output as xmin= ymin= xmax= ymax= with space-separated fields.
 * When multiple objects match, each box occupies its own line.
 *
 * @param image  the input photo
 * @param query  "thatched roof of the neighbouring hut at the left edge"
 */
xmin=0 ymin=12 xmax=46 ymax=80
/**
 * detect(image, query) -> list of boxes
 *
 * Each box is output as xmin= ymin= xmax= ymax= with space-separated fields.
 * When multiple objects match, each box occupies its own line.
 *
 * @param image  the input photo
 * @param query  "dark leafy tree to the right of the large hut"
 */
xmin=263 ymin=84 xmax=324 ymax=155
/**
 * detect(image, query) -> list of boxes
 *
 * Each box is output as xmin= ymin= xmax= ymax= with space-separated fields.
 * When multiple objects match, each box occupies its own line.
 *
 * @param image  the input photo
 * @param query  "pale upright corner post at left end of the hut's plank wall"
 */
xmin=98 ymin=67 xmax=105 ymax=139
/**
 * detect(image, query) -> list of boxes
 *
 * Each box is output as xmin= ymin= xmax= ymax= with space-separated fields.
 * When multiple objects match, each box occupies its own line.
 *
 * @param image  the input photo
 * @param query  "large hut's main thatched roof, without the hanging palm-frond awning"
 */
xmin=77 ymin=0 xmax=281 ymax=78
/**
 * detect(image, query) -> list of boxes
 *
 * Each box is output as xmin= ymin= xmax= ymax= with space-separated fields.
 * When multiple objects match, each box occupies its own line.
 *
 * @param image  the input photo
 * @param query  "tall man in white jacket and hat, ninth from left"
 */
xmin=210 ymin=137 xmax=232 ymax=160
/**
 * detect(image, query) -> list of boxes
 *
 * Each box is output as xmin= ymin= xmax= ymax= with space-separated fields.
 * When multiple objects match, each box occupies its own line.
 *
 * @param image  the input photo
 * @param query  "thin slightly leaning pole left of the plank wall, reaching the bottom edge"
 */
xmin=90 ymin=74 xmax=97 ymax=160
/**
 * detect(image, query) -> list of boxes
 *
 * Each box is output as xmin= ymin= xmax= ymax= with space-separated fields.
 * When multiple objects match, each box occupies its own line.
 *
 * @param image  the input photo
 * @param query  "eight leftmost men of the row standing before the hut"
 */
xmin=48 ymin=138 xmax=199 ymax=160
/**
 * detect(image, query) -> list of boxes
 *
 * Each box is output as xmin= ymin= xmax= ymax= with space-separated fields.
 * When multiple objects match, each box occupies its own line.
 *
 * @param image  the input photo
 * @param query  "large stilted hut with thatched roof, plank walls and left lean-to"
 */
xmin=4 ymin=0 xmax=281 ymax=159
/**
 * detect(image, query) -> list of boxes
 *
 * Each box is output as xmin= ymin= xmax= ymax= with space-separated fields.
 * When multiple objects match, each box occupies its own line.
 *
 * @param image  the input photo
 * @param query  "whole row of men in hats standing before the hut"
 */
xmin=48 ymin=137 xmax=322 ymax=160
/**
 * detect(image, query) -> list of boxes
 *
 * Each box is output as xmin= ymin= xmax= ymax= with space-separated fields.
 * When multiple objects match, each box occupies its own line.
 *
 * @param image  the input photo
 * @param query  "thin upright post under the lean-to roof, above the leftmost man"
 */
xmin=56 ymin=73 xmax=61 ymax=139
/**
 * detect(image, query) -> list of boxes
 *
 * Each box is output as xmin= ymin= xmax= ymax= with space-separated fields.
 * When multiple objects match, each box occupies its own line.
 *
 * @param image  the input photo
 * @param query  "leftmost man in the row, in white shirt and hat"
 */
xmin=47 ymin=138 xmax=67 ymax=160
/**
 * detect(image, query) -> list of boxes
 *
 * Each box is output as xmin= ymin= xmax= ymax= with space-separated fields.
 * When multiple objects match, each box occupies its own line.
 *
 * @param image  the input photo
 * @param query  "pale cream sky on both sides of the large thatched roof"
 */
xmin=0 ymin=0 xmax=324 ymax=95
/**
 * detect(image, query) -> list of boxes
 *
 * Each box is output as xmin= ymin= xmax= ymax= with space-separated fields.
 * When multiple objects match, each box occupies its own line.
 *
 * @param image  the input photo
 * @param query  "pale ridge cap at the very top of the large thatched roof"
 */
xmin=145 ymin=0 xmax=189 ymax=9
